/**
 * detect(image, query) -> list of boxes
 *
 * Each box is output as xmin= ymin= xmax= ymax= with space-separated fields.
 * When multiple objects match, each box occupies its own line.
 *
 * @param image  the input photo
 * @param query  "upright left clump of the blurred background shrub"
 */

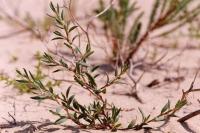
xmin=95 ymin=0 xmax=140 ymax=60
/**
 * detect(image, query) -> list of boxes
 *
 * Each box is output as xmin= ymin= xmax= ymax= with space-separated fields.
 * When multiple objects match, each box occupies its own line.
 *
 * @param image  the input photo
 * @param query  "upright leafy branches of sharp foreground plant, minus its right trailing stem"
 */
xmin=17 ymin=3 xmax=128 ymax=130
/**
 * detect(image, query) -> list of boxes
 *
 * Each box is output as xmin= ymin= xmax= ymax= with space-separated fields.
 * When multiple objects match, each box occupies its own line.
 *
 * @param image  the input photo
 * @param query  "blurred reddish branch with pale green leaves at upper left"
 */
xmin=0 ymin=6 xmax=53 ymax=40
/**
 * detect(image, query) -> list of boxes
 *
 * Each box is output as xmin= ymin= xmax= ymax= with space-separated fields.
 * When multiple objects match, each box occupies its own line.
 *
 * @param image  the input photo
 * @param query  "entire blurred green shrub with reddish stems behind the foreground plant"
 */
xmin=95 ymin=0 xmax=200 ymax=64
